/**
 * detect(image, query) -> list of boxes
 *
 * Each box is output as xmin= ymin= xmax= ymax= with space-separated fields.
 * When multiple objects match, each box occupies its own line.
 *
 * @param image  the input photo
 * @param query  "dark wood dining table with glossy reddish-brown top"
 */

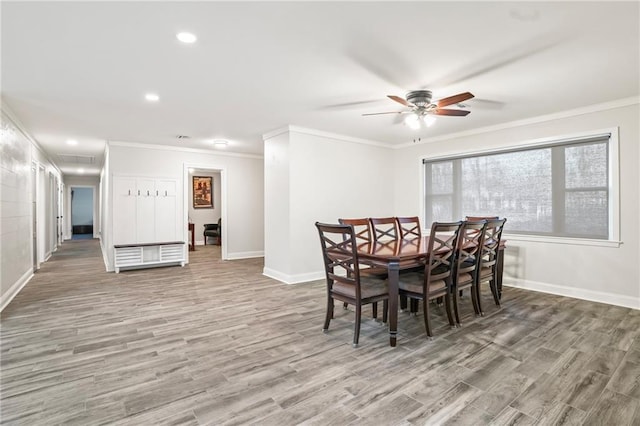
xmin=358 ymin=236 xmax=504 ymax=346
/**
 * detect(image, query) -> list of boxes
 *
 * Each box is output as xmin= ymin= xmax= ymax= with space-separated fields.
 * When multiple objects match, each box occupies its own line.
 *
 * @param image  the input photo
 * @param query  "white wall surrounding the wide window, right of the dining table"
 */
xmin=395 ymin=101 xmax=640 ymax=308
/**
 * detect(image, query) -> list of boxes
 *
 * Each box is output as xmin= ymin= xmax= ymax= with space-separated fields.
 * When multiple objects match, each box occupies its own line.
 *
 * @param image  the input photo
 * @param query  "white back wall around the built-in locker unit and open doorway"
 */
xmin=105 ymin=142 xmax=264 ymax=270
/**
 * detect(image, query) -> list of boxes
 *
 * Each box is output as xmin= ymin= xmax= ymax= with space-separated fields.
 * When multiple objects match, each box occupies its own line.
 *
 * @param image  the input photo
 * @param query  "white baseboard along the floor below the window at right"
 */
xmin=503 ymin=277 xmax=640 ymax=310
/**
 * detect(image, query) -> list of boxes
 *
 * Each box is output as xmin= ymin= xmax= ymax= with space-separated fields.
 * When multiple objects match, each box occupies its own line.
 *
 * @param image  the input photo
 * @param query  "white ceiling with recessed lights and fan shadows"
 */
xmin=1 ymin=1 xmax=640 ymax=174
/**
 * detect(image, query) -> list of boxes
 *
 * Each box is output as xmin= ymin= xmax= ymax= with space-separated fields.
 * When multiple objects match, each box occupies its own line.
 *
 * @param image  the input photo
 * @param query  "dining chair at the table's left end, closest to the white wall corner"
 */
xmin=316 ymin=222 xmax=389 ymax=347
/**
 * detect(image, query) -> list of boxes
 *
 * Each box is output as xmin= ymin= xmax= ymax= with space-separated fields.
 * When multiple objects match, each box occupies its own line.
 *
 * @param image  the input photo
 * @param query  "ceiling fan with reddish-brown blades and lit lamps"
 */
xmin=362 ymin=90 xmax=473 ymax=129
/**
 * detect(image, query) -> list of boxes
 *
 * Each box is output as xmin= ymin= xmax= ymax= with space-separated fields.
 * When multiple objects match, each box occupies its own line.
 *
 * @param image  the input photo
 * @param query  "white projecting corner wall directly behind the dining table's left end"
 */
xmin=264 ymin=127 xmax=393 ymax=283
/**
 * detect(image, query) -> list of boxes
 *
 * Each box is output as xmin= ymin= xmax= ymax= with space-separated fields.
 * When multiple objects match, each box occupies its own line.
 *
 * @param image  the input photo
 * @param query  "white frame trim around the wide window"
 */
xmin=419 ymin=127 xmax=622 ymax=247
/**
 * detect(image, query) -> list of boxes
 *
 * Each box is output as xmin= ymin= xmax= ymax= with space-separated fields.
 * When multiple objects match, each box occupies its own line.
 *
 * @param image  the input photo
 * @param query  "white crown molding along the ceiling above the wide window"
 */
xmin=393 ymin=96 xmax=640 ymax=149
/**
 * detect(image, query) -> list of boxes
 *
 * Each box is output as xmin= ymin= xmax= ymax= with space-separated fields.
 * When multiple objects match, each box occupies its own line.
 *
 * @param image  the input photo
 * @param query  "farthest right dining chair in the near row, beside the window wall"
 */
xmin=476 ymin=219 xmax=507 ymax=315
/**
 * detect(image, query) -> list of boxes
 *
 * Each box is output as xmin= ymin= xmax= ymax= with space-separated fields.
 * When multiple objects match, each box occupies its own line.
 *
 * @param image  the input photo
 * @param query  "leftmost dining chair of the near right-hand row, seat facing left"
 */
xmin=398 ymin=221 xmax=462 ymax=338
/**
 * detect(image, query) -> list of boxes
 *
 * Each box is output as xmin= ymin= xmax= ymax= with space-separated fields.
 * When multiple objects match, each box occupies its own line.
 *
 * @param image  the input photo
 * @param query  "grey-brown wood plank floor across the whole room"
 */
xmin=0 ymin=240 xmax=640 ymax=426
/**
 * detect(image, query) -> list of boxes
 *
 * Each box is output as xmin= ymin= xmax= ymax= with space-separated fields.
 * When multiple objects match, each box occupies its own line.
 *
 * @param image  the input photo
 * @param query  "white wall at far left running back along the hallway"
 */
xmin=0 ymin=105 xmax=60 ymax=310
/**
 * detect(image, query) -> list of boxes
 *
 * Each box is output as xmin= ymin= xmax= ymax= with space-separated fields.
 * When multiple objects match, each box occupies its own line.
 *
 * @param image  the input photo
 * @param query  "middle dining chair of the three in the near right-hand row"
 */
xmin=451 ymin=220 xmax=487 ymax=324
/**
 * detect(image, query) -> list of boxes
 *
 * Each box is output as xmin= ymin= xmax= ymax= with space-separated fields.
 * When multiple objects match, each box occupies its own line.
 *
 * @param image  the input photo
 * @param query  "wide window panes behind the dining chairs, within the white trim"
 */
xmin=423 ymin=134 xmax=613 ymax=239
